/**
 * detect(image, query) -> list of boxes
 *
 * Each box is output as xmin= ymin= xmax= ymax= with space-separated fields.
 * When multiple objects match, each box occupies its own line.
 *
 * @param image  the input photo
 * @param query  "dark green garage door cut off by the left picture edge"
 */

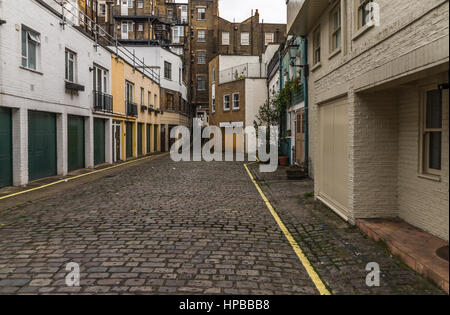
xmin=0 ymin=107 xmax=12 ymax=187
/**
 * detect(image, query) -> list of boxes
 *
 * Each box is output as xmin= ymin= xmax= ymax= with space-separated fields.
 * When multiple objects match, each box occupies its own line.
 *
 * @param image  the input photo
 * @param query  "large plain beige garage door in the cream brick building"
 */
xmin=318 ymin=98 xmax=349 ymax=217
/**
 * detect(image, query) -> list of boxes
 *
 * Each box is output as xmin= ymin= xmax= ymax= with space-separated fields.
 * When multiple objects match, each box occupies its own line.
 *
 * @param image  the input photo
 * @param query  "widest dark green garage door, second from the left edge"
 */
xmin=28 ymin=111 xmax=56 ymax=180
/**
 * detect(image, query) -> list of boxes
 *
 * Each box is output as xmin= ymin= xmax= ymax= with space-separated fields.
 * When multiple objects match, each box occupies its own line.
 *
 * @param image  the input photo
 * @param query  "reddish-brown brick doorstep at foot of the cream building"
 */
xmin=356 ymin=219 xmax=449 ymax=294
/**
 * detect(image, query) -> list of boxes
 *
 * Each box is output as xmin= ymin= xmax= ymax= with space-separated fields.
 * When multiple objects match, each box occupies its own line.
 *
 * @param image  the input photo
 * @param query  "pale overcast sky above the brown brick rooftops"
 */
xmin=177 ymin=0 xmax=287 ymax=23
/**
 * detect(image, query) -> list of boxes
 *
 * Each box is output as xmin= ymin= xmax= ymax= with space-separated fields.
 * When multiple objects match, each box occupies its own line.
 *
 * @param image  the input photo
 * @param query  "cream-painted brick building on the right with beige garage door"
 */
xmin=288 ymin=0 xmax=449 ymax=241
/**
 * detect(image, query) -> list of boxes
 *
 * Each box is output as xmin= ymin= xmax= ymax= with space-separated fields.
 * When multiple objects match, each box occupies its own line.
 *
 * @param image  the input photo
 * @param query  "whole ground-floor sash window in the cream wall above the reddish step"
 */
xmin=421 ymin=90 xmax=443 ymax=175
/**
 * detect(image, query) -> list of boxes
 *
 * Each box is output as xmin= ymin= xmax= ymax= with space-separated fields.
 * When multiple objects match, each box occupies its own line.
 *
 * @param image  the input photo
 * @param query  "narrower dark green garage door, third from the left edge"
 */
xmin=67 ymin=115 xmax=85 ymax=172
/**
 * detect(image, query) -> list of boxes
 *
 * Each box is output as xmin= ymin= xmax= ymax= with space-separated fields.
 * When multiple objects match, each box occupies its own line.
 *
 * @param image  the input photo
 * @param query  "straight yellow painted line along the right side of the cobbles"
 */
xmin=244 ymin=164 xmax=331 ymax=295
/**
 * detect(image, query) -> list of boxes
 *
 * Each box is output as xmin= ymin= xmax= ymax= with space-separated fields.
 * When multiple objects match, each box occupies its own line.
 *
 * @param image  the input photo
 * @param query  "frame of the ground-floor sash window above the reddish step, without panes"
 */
xmin=419 ymin=85 xmax=444 ymax=180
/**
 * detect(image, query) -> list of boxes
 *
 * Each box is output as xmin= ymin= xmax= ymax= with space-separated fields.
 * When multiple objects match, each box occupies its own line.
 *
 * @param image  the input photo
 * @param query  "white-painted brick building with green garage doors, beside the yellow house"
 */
xmin=0 ymin=0 xmax=112 ymax=186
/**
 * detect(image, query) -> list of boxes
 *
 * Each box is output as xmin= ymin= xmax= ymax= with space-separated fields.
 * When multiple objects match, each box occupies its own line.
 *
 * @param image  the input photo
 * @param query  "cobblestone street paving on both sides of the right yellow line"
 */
xmin=0 ymin=156 xmax=440 ymax=294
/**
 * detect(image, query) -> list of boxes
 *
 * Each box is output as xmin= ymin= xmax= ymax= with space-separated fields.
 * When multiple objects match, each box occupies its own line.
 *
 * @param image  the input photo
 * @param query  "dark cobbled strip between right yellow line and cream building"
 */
xmin=249 ymin=164 xmax=444 ymax=295
